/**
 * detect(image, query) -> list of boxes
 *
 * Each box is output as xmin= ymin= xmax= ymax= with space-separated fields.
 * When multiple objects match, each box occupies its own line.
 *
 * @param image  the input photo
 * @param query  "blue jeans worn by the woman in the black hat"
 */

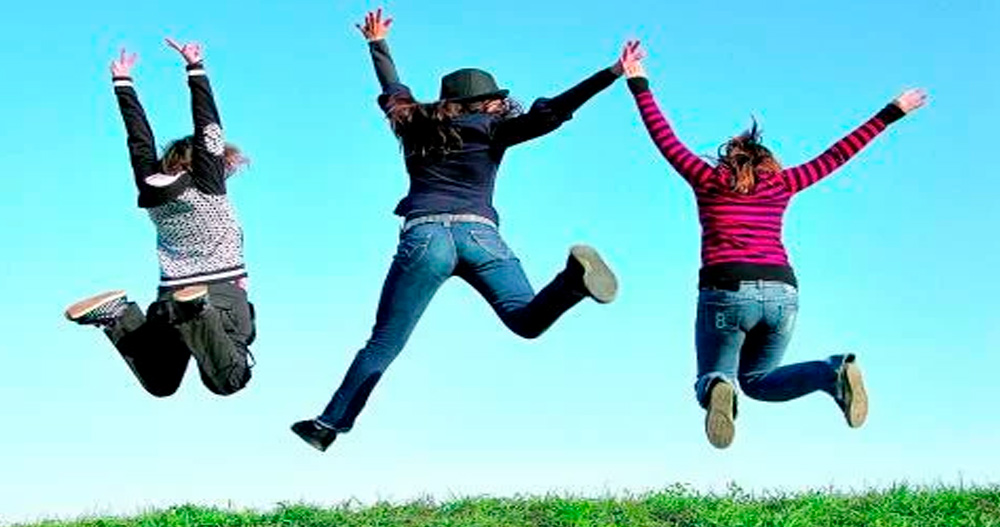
xmin=318 ymin=222 xmax=585 ymax=432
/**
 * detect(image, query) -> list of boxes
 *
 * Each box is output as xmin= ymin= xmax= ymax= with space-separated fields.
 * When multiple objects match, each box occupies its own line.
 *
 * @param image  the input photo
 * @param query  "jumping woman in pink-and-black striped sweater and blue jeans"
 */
xmin=625 ymin=44 xmax=925 ymax=448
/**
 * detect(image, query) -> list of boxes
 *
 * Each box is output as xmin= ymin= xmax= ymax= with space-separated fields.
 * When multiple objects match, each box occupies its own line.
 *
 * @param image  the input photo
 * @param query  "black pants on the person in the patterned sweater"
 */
xmin=104 ymin=283 xmax=256 ymax=397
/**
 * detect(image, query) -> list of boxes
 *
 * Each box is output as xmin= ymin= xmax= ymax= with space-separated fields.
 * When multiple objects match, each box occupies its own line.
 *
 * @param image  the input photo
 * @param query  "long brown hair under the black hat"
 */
xmin=386 ymin=95 xmax=522 ymax=157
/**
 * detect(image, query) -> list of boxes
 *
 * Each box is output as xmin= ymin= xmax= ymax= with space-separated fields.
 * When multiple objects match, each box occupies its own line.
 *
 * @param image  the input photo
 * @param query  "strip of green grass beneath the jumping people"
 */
xmin=15 ymin=486 xmax=1000 ymax=527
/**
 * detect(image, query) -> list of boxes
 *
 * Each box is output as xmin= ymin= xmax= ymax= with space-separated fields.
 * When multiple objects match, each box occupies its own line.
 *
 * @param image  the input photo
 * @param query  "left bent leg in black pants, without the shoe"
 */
xmin=104 ymin=302 xmax=191 ymax=397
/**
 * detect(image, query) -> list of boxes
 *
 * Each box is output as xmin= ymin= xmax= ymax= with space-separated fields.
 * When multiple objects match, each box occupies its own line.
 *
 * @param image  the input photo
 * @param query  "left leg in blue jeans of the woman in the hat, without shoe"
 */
xmin=318 ymin=224 xmax=455 ymax=432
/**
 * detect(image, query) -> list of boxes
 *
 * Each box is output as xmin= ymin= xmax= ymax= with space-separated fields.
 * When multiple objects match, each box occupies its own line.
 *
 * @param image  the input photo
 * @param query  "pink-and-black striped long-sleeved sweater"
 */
xmin=629 ymin=78 xmax=903 ymax=287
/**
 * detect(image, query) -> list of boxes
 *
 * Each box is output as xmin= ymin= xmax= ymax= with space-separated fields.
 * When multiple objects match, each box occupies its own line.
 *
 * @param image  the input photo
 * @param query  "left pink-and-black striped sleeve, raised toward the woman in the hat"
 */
xmin=628 ymin=77 xmax=715 ymax=188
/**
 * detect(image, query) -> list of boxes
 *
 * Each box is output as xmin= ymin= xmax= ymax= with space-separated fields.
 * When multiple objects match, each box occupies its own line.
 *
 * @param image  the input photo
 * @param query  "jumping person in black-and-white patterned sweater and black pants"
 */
xmin=66 ymin=39 xmax=255 ymax=397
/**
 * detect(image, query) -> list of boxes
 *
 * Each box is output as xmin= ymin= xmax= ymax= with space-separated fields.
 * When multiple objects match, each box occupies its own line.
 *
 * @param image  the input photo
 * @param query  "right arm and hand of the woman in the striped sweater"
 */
xmin=781 ymin=89 xmax=927 ymax=193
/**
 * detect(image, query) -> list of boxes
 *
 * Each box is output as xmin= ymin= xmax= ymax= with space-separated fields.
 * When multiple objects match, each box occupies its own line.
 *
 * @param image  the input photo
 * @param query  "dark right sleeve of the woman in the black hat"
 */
xmin=493 ymin=68 xmax=618 ymax=147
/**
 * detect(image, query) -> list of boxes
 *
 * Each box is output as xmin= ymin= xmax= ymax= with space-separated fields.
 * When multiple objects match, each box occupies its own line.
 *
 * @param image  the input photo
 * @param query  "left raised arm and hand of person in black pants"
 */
xmin=111 ymin=48 xmax=159 ymax=189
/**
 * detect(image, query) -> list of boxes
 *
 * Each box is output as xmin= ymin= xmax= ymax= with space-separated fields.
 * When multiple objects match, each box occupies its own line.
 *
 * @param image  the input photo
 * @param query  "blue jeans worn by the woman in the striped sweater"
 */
xmin=695 ymin=280 xmax=846 ymax=407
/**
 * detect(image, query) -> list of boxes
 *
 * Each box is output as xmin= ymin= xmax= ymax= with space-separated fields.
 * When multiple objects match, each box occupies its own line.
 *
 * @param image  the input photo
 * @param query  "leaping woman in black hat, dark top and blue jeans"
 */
xmin=292 ymin=9 xmax=635 ymax=451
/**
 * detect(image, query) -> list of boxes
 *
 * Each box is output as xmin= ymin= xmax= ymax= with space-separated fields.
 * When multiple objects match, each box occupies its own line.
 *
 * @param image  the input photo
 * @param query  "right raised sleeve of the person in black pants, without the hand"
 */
xmin=187 ymin=62 xmax=226 ymax=195
